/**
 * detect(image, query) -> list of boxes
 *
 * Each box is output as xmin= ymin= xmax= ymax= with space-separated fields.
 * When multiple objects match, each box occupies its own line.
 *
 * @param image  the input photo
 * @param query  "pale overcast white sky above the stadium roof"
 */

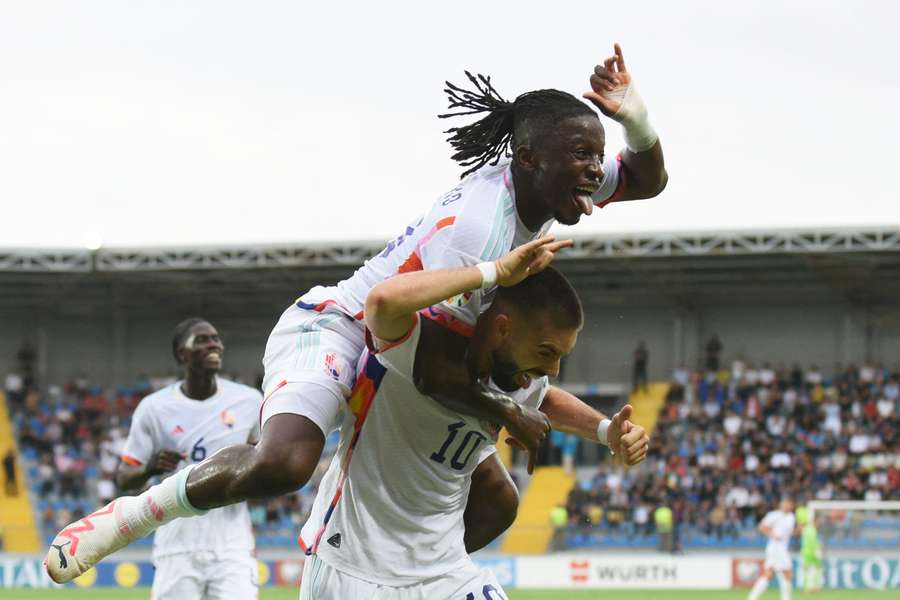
xmin=0 ymin=0 xmax=900 ymax=248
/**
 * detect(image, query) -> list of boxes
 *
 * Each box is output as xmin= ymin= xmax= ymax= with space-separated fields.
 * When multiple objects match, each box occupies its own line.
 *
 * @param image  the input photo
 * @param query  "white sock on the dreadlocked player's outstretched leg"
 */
xmin=117 ymin=465 xmax=206 ymax=539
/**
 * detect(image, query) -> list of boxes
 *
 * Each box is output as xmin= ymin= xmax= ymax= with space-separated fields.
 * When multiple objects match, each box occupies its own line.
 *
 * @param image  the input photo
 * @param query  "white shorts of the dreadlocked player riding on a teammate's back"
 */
xmin=260 ymin=304 xmax=366 ymax=436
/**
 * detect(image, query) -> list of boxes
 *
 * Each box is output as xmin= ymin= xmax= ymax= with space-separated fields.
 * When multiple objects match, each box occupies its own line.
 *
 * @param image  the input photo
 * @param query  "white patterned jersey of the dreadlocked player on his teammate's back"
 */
xmin=297 ymin=156 xmax=624 ymax=334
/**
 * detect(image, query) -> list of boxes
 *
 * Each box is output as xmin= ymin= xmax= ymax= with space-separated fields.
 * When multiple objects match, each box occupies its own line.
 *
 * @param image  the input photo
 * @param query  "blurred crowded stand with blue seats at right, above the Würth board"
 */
xmin=557 ymin=361 xmax=900 ymax=549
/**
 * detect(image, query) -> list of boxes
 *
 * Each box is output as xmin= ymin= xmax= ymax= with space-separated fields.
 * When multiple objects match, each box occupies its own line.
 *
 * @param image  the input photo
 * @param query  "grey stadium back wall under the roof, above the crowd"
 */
xmin=0 ymin=300 xmax=900 ymax=385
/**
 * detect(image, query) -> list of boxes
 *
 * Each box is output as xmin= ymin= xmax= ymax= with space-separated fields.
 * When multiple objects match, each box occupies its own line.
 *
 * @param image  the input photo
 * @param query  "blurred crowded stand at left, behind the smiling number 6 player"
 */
xmin=0 ymin=375 xmax=337 ymax=551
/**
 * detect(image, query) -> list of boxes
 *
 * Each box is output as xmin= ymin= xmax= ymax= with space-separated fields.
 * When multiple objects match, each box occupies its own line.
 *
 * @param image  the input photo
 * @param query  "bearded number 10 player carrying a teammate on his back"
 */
xmin=300 ymin=237 xmax=646 ymax=600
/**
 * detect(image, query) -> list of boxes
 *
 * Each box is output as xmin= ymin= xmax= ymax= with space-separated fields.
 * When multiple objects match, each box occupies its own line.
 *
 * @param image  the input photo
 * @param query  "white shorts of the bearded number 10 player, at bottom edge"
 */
xmin=300 ymin=556 xmax=508 ymax=600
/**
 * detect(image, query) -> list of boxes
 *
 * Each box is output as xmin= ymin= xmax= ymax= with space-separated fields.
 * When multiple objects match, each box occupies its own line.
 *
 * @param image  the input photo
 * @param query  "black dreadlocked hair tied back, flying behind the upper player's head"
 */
xmin=438 ymin=71 xmax=597 ymax=178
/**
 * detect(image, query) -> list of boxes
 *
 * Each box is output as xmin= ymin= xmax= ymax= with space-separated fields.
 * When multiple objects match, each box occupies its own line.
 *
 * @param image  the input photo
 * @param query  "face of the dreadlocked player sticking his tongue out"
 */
xmin=515 ymin=115 xmax=606 ymax=225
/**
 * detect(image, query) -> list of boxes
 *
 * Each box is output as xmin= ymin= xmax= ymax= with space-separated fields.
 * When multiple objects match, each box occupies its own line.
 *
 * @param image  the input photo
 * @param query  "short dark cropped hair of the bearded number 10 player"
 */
xmin=494 ymin=267 xmax=584 ymax=329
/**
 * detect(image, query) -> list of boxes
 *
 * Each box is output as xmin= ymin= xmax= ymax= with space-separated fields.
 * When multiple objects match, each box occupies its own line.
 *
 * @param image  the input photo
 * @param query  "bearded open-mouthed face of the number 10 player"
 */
xmin=488 ymin=310 xmax=581 ymax=392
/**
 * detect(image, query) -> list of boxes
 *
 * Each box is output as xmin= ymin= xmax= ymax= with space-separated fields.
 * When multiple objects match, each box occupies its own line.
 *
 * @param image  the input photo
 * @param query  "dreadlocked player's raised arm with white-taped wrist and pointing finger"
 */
xmin=583 ymin=44 xmax=669 ymax=201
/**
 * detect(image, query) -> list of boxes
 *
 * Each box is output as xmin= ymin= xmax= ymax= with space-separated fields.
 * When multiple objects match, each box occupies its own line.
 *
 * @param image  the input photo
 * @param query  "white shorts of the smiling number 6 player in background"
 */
xmin=150 ymin=552 xmax=259 ymax=600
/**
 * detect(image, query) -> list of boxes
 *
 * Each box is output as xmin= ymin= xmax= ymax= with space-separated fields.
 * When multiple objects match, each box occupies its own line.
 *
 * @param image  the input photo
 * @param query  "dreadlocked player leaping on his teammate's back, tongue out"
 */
xmin=47 ymin=46 xmax=666 ymax=582
